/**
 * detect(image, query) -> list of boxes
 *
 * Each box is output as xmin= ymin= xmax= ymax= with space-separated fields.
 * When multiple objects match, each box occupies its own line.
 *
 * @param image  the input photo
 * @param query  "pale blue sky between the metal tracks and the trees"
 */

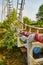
xmin=0 ymin=0 xmax=43 ymax=21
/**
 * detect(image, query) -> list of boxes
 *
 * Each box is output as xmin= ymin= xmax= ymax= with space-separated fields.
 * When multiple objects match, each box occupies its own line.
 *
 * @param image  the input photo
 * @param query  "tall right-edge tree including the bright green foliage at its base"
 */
xmin=32 ymin=5 xmax=43 ymax=27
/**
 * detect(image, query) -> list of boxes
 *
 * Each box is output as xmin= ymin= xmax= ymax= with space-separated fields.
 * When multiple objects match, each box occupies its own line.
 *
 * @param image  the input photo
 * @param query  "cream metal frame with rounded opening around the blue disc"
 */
xmin=30 ymin=42 xmax=43 ymax=65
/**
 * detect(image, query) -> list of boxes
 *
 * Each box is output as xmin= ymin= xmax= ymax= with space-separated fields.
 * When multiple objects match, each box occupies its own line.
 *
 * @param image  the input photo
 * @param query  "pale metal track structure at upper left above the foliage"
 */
xmin=1 ymin=0 xmax=13 ymax=21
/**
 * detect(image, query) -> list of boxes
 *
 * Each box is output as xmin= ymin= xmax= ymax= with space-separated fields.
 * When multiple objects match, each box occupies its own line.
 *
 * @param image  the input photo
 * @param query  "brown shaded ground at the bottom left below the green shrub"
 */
xmin=0 ymin=47 xmax=27 ymax=65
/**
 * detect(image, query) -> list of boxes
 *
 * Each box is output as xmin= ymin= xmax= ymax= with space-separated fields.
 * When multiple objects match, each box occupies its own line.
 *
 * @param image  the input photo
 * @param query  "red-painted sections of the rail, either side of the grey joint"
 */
xmin=20 ymin=31 xmax=43 ymax=43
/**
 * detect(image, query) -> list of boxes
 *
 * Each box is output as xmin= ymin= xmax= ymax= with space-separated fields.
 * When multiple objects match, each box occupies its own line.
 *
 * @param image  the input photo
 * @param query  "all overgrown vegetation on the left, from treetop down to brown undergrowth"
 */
xmin=0 ymin=10 xmax=26 ymax=65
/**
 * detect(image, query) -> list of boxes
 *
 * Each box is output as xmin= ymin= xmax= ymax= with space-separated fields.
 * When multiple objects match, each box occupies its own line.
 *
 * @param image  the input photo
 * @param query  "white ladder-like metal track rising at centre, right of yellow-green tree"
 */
xmin=17 ymin=0 xmax=25 ymax=22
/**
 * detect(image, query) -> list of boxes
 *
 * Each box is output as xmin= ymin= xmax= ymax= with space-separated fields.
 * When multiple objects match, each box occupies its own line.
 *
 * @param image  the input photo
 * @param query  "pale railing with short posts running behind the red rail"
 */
xmin=20 ymin=22 xmax=43 ymax=33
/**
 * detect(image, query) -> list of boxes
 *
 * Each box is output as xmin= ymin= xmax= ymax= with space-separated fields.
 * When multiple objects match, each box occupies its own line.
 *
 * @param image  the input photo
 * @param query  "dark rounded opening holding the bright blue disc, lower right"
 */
xmin=33 ymin=47 xmax=43 ymax=59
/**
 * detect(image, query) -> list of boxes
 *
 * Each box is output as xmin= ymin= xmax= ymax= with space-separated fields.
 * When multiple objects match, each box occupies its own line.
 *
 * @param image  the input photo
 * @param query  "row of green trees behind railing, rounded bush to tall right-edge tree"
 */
xmin=23 ymin=5 xmax=43 ymax=27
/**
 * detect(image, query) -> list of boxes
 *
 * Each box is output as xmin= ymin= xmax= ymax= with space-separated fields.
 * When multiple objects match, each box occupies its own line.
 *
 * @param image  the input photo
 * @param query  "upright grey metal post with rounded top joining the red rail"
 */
xmin=27 ymin=34 xmax=35 ymax=65
